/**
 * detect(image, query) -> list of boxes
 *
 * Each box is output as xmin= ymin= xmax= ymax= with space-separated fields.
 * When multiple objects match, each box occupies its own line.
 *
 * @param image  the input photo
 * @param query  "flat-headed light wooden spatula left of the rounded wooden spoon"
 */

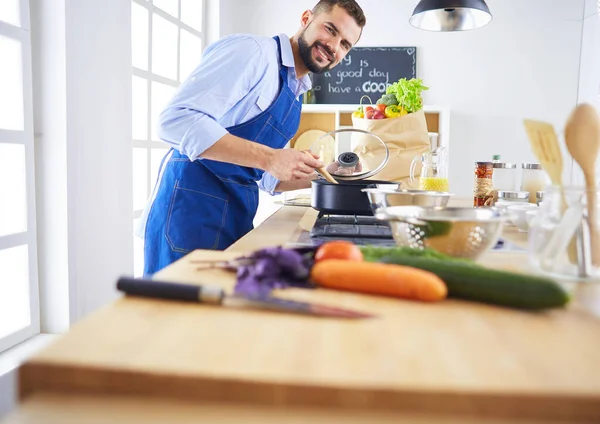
xmin=524 ymin=119 xmax=577 ymax=264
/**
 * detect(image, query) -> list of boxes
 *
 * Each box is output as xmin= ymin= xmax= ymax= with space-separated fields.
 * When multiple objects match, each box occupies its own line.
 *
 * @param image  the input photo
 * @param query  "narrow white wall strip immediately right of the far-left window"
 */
xmin=31 ymin=0 xmax=74 ymax=333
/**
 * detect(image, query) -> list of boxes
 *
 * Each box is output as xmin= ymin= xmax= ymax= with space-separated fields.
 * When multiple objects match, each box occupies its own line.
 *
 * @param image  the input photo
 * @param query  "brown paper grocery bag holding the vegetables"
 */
xmin=351 ymin=109 xmax=430 ymax=188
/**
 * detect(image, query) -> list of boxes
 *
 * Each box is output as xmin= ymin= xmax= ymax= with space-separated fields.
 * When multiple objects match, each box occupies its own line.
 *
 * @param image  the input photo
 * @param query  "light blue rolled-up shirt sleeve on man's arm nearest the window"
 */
xmin=157 ymin=36 xmax=265 ymax=160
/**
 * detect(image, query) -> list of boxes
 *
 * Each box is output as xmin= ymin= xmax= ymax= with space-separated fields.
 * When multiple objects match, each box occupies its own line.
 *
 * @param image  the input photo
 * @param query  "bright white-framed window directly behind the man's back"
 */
xmin=131 ymin=0 xmax=205 ymax=276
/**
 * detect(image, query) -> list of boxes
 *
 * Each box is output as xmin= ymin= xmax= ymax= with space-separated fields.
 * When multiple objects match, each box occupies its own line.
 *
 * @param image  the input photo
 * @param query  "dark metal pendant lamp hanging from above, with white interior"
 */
xmin=409 ymin=0 xmax=492 ymax=31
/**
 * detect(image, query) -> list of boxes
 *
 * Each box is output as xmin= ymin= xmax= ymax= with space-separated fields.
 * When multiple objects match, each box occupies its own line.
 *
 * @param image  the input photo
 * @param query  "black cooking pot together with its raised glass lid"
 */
xmin=311 ymin=128 xmax=399 ymax=215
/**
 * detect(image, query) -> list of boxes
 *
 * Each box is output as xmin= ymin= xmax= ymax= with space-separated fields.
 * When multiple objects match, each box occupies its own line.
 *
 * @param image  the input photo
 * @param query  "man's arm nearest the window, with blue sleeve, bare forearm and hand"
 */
xmin=158 ymin=36 xmax=322 ymax=181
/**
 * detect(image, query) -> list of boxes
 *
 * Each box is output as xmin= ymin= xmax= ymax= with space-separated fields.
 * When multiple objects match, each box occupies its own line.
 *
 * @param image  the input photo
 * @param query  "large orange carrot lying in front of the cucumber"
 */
xmin=311 ymin=259 xmax=448 ymax=301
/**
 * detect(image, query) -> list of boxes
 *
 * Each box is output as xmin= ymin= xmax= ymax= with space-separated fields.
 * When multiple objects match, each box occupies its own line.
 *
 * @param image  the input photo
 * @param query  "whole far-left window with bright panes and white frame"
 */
xmin=0 ymin=0 xmax=40 ymax=352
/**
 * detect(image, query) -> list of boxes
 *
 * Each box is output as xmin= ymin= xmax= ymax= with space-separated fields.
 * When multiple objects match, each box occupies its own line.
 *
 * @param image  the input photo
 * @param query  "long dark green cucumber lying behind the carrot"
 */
xmin=381 ymin=255 xmax=570 ymax=309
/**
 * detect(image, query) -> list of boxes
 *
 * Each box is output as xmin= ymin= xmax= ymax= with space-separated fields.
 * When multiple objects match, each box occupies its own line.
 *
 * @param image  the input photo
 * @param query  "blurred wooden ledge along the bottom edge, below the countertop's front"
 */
xmin=5 ymin=393 xmax=597 ymax=424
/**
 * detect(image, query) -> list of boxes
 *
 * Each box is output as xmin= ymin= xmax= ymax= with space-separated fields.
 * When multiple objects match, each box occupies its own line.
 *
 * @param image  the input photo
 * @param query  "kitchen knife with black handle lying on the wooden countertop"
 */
xmin=117 ymin=277 xmax=373 ymax=318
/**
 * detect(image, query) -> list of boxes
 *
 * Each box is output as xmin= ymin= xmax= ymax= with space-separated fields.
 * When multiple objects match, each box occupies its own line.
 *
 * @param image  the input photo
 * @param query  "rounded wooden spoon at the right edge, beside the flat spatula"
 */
xmin=565 ymin=104 xmax=600 ymax=266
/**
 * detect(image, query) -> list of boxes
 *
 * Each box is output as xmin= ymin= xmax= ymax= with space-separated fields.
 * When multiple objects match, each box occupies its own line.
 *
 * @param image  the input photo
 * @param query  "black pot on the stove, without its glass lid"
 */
xmin=310 ymin=179 xmax=398 ymax=215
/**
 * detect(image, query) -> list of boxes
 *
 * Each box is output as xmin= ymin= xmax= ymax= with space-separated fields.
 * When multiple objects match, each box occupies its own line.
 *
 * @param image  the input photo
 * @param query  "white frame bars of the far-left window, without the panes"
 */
xmin=0 ymin=0 xmax=40 ymax=352
